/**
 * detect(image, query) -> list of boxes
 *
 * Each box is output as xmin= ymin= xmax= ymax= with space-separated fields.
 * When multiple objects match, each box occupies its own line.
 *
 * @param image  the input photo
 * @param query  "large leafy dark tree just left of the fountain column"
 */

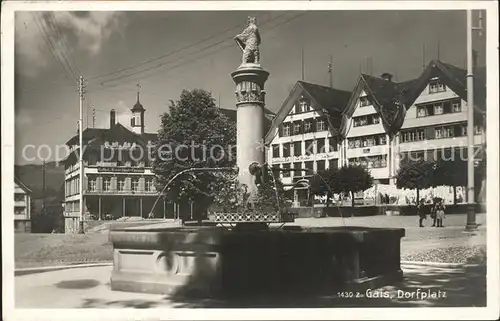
xmin=152 ymin=89 xmax=236 ymax=216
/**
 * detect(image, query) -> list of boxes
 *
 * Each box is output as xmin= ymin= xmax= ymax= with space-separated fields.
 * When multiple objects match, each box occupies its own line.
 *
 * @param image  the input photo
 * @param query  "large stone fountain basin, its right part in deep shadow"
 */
xmin=109 ymin=225 xmax=405 ymax=297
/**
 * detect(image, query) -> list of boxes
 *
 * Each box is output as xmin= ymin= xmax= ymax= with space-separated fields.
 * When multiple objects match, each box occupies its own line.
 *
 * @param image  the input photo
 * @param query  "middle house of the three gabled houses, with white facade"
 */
xmin=341 ymin=73 xmax=415 ymax=184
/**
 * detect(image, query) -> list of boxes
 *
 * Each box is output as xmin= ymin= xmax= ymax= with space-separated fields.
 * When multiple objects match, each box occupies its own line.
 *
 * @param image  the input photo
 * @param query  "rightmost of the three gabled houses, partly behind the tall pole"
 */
xmin=396 ymin=60 xmax=486 ymax=170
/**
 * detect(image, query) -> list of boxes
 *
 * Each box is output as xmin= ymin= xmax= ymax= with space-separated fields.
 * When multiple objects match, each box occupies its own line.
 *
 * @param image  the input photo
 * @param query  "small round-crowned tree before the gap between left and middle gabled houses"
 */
xmin=329 ymin=165 xmax=373 ymax=207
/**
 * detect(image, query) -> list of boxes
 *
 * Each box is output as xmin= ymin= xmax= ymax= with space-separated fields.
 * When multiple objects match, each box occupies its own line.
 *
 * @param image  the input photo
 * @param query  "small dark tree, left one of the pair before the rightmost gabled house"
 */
xmin=396 ymin=160 xmax=436 ymax=202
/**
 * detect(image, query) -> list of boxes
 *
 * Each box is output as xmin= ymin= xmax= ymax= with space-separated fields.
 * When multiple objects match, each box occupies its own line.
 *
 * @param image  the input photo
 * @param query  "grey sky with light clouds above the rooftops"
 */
xmin=14 ymin=11 xmax=485 ymax=164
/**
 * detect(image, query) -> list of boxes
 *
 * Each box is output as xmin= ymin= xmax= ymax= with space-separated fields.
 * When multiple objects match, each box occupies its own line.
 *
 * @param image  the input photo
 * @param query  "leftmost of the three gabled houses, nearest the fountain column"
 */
xmin=265 ymin=81 xmax=350 ymax=203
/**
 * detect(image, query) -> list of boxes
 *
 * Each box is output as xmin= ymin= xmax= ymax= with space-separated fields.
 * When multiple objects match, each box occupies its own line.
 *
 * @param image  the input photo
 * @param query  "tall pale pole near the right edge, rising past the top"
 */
xmin=465 ymin=10 xmax=482 ymax=231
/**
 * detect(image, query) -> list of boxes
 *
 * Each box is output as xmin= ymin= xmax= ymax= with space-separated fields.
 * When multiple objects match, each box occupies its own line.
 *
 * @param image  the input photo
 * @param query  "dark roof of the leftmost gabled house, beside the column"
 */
xmin=265 ymin=81 xmax=351 ymax=144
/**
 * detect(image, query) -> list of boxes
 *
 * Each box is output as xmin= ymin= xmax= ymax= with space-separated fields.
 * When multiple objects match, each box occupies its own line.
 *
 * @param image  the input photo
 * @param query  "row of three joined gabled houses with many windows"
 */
xmin=266 ymin=61 xmax=486 ymax=205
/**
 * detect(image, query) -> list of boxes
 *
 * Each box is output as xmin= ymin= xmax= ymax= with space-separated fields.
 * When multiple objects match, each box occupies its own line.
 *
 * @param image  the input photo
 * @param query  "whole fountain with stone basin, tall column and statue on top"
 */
xmin=110 ymin=18 xmax=405 ymax=297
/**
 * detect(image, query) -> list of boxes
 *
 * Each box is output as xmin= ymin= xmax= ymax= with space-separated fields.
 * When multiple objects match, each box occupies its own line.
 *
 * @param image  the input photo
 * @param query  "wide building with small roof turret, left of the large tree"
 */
xmin=64 ymin=89 xmax=274 ymax=233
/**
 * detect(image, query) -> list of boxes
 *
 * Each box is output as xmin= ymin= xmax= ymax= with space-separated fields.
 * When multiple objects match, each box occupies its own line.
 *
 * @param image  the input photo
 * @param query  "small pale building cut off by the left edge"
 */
xmin=14 ymin=177 xmax=32 ymax=233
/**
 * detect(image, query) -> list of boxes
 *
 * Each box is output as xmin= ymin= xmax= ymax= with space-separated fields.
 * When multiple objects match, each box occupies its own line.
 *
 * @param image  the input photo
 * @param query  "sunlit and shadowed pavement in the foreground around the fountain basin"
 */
xmin=15 ymin=265 xmax=486 ymax=309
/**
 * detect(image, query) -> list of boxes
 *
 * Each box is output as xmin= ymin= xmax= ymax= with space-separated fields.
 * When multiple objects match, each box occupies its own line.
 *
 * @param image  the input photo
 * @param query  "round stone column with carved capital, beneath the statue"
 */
xmin=231 ymin=64 xmax=269 ymax=194
